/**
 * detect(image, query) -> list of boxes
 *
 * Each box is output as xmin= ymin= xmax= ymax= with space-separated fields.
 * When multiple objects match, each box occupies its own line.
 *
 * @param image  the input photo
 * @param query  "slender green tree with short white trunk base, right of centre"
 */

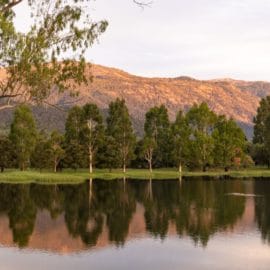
xmin=172 ymin=111 xmax=191 ymax=173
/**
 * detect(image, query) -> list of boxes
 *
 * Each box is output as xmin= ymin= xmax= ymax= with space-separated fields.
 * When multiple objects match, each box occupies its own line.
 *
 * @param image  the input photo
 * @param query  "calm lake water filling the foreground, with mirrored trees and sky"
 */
xmin=0 ymin=178 xmax=270 ymax=270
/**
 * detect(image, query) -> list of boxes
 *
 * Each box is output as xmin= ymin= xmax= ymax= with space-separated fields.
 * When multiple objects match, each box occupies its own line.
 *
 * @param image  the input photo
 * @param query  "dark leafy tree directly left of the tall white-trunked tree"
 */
xmin=65 ymin=106 xmax=85 ymax=169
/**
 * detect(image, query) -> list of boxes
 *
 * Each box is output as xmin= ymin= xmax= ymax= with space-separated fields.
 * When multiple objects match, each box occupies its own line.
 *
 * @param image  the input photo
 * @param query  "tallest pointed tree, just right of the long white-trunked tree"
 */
xmin=107 ymin=98 xmax=136 ymax=173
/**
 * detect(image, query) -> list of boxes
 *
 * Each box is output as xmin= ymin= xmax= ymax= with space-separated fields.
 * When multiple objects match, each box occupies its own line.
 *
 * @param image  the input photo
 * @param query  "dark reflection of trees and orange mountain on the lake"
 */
xmin=0 ymin=179 xmax=270 ymax=252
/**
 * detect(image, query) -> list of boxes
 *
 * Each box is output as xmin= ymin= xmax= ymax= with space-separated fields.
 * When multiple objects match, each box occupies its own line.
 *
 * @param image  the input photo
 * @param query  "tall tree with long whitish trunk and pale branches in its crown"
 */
xmin=82 ymin=104 xmax=104 ymax=173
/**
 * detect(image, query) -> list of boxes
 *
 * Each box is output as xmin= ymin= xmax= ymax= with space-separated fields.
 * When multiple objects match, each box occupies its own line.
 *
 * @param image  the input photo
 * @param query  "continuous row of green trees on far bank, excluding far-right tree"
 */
xmin=0 ymin=99 xmax=253 ymax=172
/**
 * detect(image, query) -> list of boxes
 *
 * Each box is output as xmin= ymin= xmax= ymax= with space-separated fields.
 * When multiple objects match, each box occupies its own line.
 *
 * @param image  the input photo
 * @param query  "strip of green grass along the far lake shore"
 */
xmin=0 ymin=168 xmax=270 ymax=184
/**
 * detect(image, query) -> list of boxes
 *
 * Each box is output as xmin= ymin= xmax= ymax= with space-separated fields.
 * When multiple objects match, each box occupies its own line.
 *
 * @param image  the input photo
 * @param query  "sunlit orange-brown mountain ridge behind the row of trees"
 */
xmin=0 ymin=65 xmax=270 ymax=138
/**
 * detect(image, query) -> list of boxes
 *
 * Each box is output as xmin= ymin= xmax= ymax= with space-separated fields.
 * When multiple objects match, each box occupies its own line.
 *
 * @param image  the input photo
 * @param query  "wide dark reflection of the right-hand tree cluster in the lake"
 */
xmin=132 ymin=179 xmax=245 ymax=246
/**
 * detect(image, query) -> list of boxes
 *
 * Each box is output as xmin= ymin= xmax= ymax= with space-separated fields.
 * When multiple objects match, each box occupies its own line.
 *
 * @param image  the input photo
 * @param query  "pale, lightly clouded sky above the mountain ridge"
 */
xmin=16 ymin=0 xmax=270 ymax=81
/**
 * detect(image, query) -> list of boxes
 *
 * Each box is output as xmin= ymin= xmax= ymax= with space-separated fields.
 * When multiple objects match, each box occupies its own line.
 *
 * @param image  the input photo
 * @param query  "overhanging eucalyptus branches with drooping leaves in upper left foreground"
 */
xmin=0 ymin=0 xmax=108 ymax=109
